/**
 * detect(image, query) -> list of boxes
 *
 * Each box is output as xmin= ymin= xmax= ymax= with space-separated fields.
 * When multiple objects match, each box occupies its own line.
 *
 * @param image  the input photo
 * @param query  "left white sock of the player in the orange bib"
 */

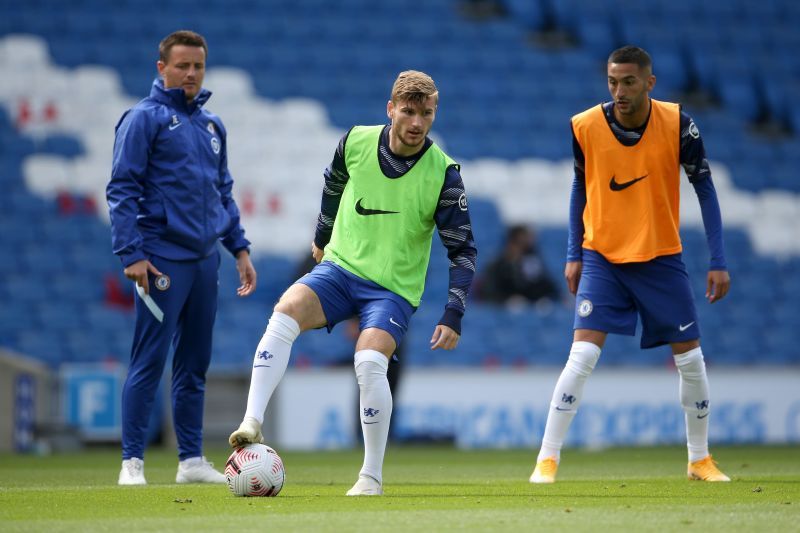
xmin=536 ymin=341 xmax=600 ymax=462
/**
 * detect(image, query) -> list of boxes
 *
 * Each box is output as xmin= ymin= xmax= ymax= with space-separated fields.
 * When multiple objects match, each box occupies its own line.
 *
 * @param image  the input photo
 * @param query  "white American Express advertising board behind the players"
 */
xmin=277 ymin=368 xmax=800 ymax=449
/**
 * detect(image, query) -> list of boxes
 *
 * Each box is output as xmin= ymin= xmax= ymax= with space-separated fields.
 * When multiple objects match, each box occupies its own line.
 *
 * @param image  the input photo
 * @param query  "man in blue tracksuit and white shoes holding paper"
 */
xmin=106 ymin=31 xmax=256 ymax=485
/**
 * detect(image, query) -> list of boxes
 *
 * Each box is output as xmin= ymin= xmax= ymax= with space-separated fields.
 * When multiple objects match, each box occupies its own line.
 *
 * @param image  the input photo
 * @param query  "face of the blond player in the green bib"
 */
xmin=386 ymin=96 xmax=436 ymax=155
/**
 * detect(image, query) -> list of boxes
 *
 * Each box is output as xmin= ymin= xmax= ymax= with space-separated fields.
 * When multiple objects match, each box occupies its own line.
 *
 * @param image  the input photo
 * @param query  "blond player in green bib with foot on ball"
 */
xmin=229 ymin=71 xmax=477 ymax=496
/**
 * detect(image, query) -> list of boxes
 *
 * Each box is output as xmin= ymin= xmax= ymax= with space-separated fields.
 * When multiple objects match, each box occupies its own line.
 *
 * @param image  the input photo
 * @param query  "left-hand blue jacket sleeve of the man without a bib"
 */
xmin=106 ymin=109 xmax=150 ymax=267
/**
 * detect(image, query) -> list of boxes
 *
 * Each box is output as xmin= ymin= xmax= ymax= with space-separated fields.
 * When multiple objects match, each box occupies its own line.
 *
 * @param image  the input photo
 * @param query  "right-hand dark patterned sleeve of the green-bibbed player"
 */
xmin=433 ymin=165 xmax=478 ymax=335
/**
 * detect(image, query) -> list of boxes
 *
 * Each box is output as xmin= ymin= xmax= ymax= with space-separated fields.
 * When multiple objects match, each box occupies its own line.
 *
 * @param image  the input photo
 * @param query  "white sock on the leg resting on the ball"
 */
xmin=244 ymin=311 xmax=300 ymax=423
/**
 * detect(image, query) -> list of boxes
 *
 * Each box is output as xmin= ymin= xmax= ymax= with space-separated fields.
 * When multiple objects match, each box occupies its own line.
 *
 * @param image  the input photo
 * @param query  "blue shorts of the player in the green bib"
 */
xmin=297 ymin=261 xmax=416 ymax=346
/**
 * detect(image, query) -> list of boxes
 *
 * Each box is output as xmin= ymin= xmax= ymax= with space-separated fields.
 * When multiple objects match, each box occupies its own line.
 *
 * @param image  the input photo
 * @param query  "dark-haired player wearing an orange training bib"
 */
xmin=530 ymin=46 xmax=730 ymax=483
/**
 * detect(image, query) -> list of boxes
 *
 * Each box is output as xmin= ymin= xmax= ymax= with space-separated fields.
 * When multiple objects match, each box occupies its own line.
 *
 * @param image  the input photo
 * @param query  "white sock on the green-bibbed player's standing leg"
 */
xmin=355 ymin=350 xmax=392 ymax=483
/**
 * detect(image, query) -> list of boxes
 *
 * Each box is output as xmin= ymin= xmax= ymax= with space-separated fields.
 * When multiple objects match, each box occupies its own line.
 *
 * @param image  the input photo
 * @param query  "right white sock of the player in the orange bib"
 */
xmin=674 ymin=346 xmax=710 ymax=462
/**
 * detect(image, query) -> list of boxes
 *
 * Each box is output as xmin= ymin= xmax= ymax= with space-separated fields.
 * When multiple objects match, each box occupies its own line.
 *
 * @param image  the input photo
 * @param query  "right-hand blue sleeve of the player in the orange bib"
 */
xmin=680 ymin=111 xmax=728 ymax=270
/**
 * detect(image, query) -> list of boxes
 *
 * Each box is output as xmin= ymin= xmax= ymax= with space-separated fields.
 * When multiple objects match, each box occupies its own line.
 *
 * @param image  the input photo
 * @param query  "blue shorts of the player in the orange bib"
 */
xmin=574 ymin=250 xmax=700 ymax=348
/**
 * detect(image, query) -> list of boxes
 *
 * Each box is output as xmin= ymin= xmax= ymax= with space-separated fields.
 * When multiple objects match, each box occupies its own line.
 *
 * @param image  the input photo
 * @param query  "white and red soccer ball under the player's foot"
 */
xmin=225 ymin=444 xmax=286 ymax=496
